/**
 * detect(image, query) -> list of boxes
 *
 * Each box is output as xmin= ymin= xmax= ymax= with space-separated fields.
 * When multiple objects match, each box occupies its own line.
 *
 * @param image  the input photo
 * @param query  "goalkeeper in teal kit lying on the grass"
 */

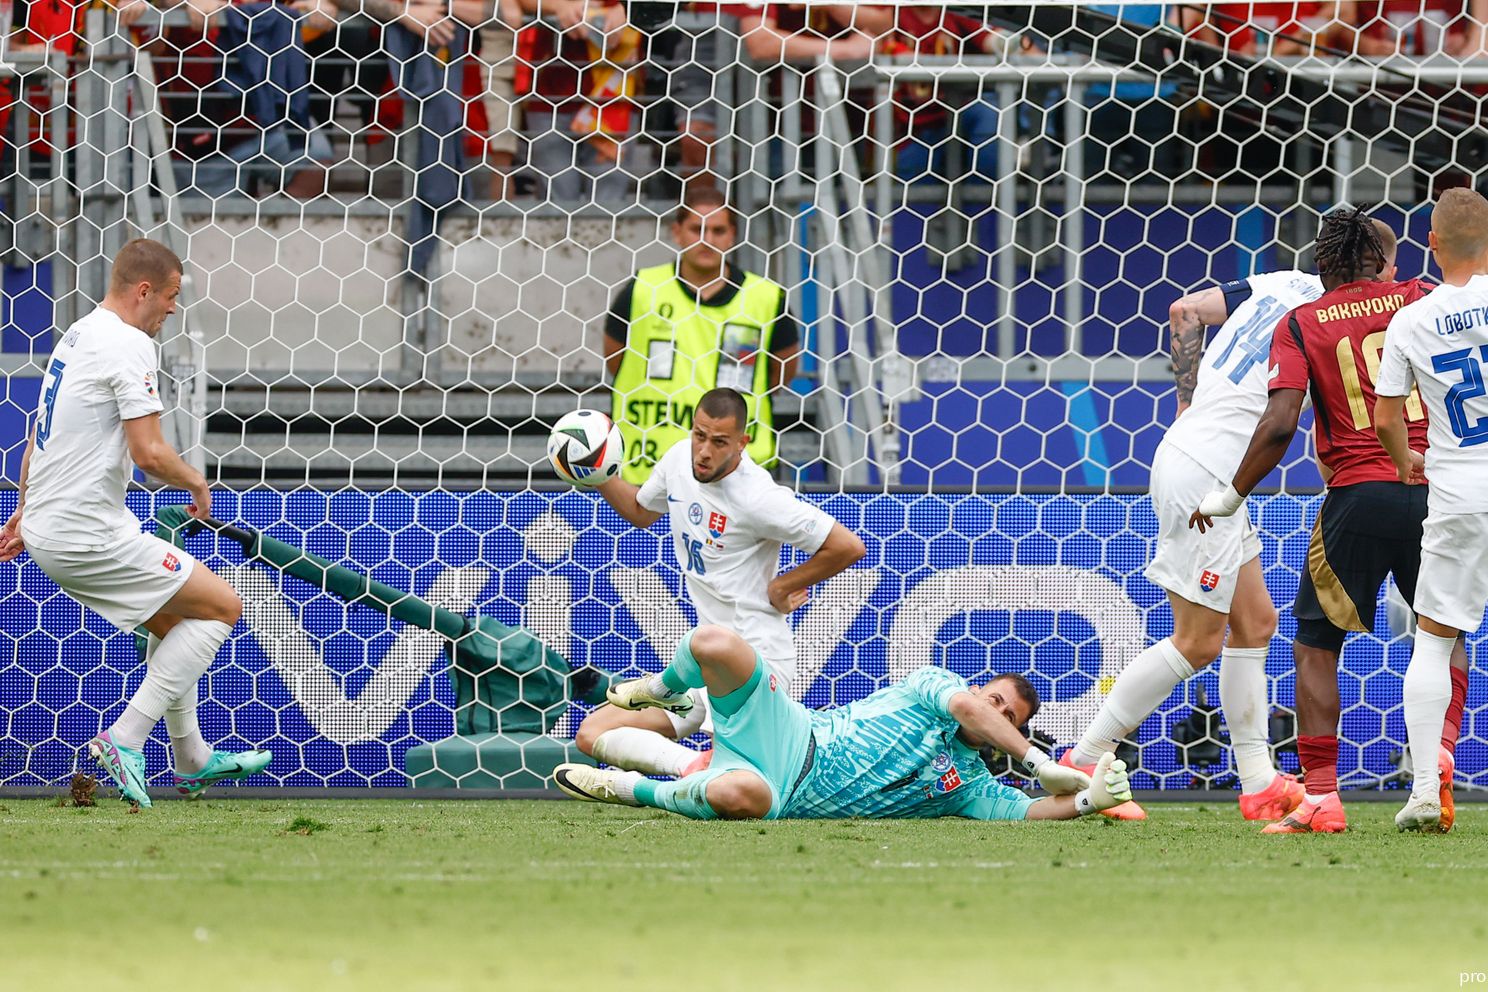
xmin=554 ymin=626 xmax=1131 ymax=819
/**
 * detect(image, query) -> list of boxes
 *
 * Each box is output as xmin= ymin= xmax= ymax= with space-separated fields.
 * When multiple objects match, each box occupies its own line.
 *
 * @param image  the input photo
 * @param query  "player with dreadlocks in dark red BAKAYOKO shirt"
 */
xmin=1189 ymin=208 xmax=1467 ymax=833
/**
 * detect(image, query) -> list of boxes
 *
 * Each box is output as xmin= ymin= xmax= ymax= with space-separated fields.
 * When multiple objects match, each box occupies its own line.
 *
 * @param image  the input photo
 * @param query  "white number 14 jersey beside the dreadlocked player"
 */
xmin=1162 ymin=269 xmax=1323 ymax=482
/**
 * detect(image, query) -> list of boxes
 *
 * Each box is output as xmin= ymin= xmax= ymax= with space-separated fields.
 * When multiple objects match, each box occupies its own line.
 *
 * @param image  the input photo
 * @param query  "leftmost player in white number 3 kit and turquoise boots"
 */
xmin=0 ymin=238 xmax=271 ymax=806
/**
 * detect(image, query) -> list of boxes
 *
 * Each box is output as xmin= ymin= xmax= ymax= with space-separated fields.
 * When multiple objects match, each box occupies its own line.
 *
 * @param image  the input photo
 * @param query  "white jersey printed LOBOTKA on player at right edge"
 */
xmin=1375 ymin=275 xmax=1488 ymax=513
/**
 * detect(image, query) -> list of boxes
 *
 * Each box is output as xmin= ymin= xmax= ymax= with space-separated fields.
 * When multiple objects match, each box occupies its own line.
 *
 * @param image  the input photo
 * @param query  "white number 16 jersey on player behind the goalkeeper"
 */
xmin=635 ymin=440 xmax=833 ymax=680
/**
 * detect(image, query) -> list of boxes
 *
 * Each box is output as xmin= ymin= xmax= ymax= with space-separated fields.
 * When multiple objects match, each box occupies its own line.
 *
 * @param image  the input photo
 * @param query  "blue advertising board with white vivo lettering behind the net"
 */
xmin=0 ymin=491 xmax=1488 ymax=787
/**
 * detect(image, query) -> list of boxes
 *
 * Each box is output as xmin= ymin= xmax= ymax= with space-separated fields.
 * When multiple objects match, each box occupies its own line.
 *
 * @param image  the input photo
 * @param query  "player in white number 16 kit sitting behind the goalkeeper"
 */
xmin=576 ymin=388 xmax=868 ymax=776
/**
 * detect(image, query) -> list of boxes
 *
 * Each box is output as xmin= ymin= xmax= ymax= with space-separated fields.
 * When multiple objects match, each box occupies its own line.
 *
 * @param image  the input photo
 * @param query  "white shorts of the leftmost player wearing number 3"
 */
xmin=27 ymin=534 xmax=196 ymax=632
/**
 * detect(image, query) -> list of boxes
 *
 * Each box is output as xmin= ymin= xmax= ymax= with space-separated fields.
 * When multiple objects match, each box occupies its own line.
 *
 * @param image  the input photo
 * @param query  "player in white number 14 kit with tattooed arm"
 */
xmin=1061 ymin=271 xmax=1323 ymax=819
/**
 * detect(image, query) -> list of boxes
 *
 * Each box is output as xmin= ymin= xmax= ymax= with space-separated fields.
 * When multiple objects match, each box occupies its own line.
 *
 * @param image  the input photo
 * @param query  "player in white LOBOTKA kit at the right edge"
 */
xmin=1375 ymin=189 xmax=1488 ymax=833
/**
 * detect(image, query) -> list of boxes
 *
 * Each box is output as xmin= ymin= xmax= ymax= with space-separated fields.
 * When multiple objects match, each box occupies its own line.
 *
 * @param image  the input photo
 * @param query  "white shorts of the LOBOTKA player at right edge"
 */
xmin=1414 ymin=510 xmax=1488 ymax=634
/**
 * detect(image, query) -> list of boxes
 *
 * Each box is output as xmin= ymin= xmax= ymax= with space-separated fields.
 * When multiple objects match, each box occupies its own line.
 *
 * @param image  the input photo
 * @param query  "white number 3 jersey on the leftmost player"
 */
xmin=21 ymin=306 xmax=165 ymax=550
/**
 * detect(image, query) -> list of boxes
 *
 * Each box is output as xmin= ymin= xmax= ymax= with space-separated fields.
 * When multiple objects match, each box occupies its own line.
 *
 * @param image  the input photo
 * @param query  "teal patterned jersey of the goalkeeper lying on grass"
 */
xmin=781 ymin=666 xmax=1034 ymax=819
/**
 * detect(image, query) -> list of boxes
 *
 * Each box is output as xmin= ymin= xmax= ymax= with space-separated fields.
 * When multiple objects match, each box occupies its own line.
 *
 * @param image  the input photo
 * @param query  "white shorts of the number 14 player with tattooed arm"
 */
xmin=1144 ymin=445 xmax=1260 ymax=613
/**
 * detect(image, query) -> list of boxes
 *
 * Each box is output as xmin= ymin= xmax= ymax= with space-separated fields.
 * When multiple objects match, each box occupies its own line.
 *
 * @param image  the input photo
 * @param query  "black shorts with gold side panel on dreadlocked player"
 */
xmin=1292 ymin=482 xmax=1427 ymax=651
